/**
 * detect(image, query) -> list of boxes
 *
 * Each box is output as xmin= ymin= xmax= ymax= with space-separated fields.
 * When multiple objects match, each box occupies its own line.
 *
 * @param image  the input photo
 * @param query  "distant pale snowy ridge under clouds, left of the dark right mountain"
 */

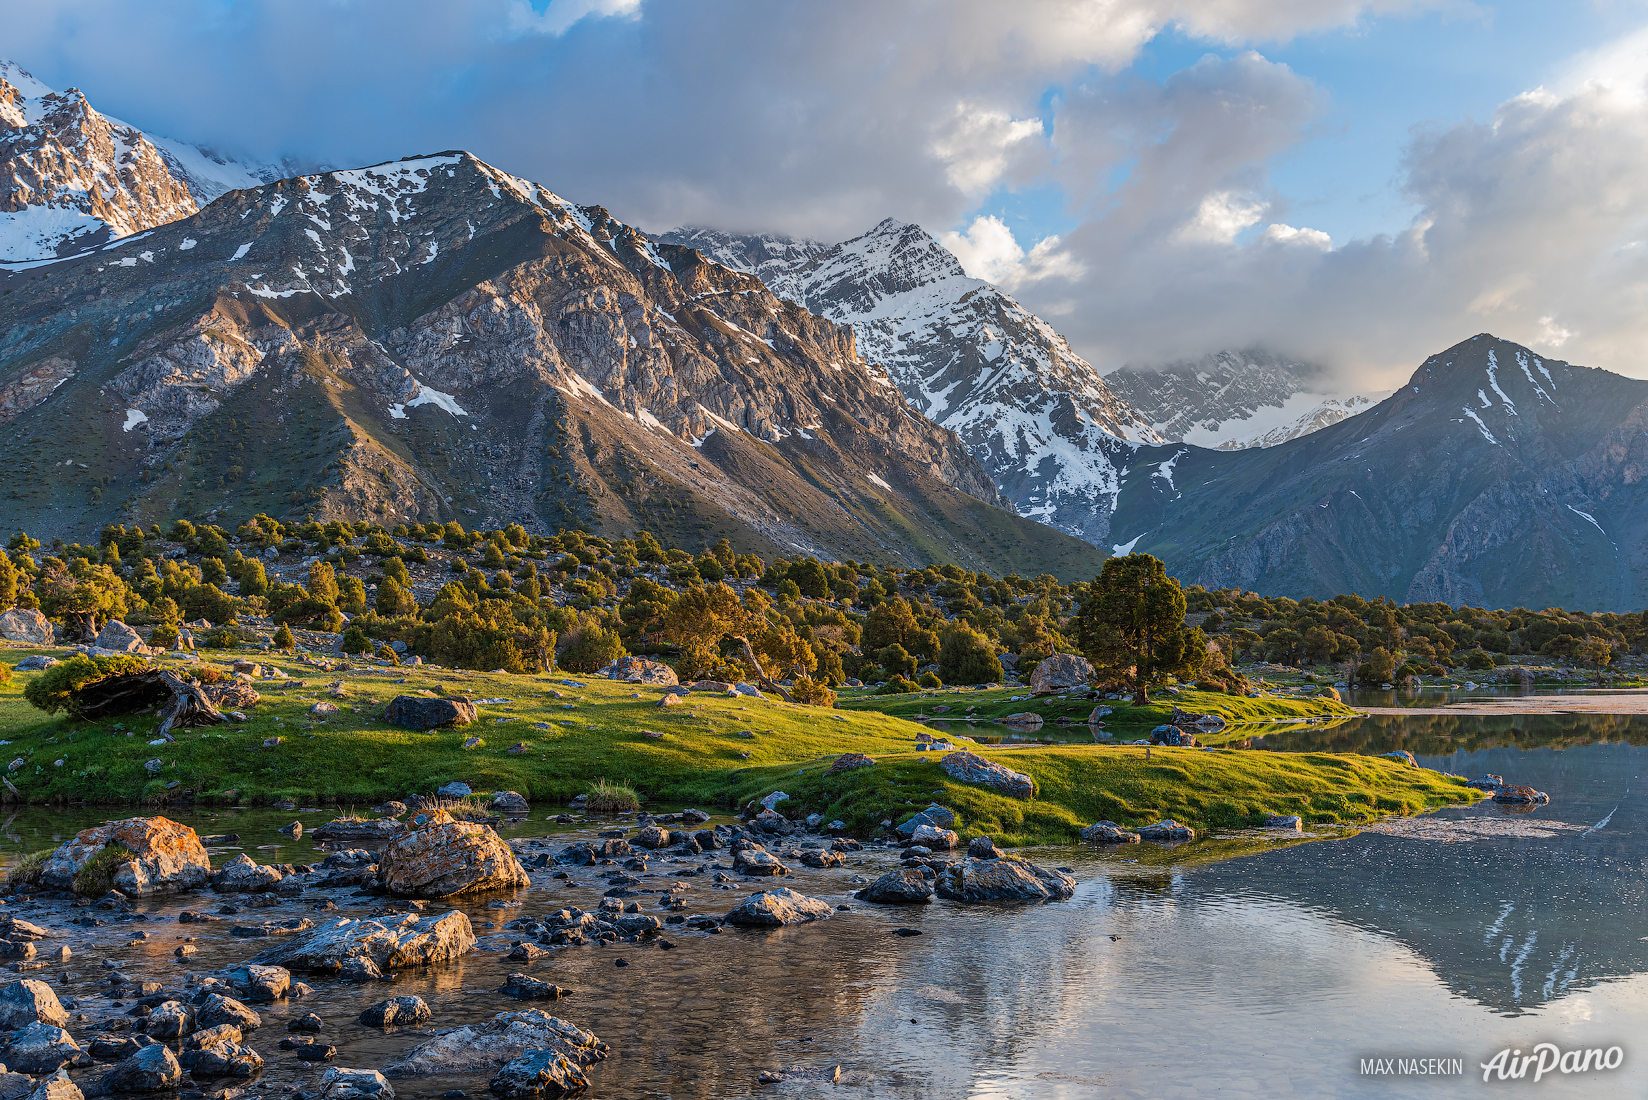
xmin=1104 ymin=348 xmax=1373 ymax=450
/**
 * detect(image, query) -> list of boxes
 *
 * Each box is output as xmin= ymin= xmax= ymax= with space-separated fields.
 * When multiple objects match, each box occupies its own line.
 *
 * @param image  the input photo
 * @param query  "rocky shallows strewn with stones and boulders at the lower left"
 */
xmin=0 ymin=808 xmax=1107 ymax=1100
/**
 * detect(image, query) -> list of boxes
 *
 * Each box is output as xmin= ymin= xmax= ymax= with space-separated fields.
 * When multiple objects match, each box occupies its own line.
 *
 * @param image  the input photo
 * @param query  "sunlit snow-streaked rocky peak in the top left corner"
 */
xmin=0 ymin=63 xmax=198 ymax=261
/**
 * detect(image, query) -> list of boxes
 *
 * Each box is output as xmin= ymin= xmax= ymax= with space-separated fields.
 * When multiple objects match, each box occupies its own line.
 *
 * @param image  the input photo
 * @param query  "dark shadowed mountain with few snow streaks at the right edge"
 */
xmin=1111 ymin=335 xmax=1648 ymax=610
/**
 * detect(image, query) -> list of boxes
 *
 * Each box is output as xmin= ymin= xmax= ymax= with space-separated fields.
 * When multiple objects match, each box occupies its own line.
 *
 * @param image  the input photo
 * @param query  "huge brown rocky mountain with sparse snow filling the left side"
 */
xmin=0 ymin=153 xmax=1103 ymax=577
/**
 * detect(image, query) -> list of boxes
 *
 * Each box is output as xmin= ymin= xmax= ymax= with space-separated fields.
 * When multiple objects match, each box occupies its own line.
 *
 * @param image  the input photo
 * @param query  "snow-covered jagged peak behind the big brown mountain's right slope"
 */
xmin=661 ymin=218 xmax=1162 ymax=546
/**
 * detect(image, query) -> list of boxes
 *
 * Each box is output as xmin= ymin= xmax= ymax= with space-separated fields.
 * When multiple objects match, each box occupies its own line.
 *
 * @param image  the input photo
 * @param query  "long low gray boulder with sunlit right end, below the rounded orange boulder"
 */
xmin=252 ymin=910 xmax=475 ymax=975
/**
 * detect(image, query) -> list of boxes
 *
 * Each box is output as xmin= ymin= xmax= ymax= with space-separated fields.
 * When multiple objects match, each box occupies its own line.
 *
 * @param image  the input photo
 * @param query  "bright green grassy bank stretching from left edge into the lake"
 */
xmin=0 ymin=650 xmax=1475 ymax=844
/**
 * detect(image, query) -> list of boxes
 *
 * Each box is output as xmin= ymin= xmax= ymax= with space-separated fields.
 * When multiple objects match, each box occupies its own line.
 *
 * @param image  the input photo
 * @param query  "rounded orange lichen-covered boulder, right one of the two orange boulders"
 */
xmin=377 ymin=810 xmax=529 ymax=897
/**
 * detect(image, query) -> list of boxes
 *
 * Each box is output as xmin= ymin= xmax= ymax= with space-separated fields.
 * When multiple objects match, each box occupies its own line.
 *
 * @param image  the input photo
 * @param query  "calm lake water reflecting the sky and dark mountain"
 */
xmin=3 ymin=716 xmax=1648 ymax=1100
